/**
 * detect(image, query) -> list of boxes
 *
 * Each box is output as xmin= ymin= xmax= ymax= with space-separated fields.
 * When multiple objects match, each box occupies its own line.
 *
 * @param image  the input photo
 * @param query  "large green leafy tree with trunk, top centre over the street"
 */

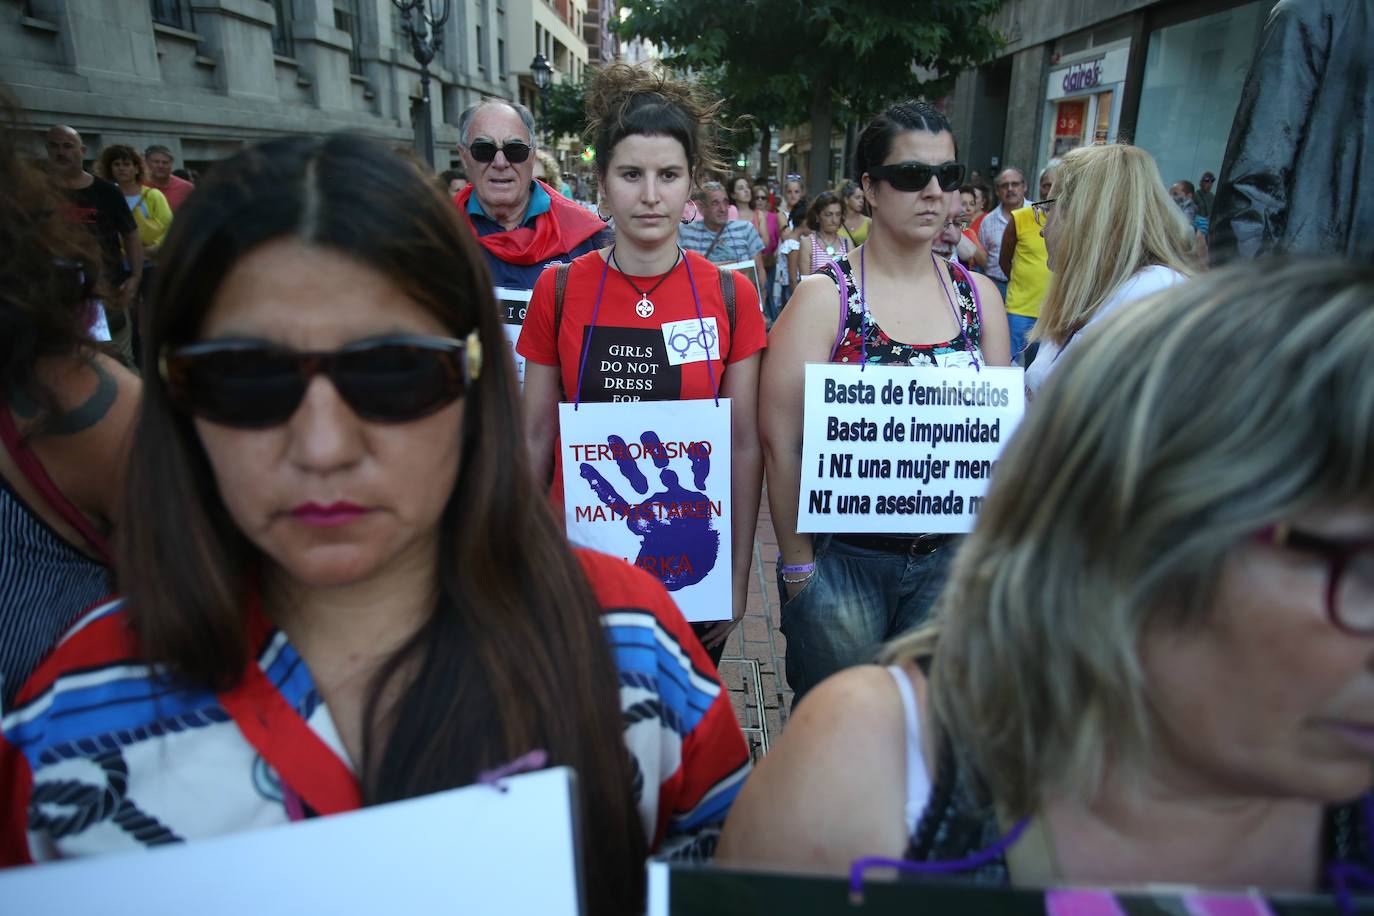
xmin=616 ymin=0 xmax=1003 ymax=192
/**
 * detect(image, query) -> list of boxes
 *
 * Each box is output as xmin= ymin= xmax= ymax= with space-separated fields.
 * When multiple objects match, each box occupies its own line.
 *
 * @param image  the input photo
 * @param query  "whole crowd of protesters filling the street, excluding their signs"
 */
xmin=0 ymin=14 xmax=1374 ymax=913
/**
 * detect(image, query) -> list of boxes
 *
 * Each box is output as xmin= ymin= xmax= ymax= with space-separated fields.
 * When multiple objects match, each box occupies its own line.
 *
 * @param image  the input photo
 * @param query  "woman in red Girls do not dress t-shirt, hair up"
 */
xmin=515 ymin=65 xmax=767 ymax=661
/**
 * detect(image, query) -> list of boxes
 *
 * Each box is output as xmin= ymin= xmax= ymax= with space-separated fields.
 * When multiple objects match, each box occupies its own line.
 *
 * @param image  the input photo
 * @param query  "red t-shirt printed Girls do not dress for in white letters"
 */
xmin=515 ymin=251 xmax=768 ymax=503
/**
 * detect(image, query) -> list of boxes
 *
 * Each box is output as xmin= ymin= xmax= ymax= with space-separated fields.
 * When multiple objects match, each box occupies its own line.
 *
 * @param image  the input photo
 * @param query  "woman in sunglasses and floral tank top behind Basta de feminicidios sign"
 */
xmin=758 ymin=102 xmax=1009 ymax=702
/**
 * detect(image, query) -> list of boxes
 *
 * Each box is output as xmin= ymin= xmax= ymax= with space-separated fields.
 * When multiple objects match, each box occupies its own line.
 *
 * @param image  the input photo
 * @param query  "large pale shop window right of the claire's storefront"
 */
xmin=1135 ymin=0 xmax=1274 ymax=184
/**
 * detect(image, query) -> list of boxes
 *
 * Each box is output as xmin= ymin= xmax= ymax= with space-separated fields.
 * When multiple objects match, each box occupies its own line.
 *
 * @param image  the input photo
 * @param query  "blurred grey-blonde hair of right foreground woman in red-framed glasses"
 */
xmin=883 ymin=261 xmax=1374 ymax=817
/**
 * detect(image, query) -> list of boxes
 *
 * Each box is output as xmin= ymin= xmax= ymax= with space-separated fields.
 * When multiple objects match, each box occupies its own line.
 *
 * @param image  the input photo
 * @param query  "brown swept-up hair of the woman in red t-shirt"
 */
xmin=587 ymin=63 xmax=725 ymax=177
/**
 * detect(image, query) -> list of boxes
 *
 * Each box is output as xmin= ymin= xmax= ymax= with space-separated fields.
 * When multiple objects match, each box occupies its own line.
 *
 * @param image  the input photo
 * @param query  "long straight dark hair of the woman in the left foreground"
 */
xmin=120 ymin=135 xmax=647 ymax=913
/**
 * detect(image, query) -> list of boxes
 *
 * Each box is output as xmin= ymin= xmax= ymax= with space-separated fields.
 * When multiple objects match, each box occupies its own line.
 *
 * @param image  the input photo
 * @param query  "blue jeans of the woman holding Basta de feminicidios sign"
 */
xmin=778 ymin=534 xmax=958 ymax=707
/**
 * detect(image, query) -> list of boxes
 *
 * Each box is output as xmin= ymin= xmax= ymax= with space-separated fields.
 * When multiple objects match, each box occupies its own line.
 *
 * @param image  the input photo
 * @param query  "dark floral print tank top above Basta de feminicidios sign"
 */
xmin=818 ymin=255 xmax=982 ymax=368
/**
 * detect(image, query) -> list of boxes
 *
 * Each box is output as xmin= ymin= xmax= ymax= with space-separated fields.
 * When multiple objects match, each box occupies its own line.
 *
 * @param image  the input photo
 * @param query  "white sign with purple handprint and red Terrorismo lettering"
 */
xmin=558 ymin=398 xmax=732 ymax=622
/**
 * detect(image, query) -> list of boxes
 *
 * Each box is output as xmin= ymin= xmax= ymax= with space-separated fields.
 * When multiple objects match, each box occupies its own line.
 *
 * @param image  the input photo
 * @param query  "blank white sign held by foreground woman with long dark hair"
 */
xmin=0 ymin=768 xmax=583 ymax=916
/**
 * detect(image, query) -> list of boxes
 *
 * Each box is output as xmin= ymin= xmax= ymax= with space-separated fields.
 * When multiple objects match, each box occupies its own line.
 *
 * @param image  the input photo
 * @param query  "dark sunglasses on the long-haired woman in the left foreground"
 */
xmin=158 ymin=331 xmax=482 ymax=428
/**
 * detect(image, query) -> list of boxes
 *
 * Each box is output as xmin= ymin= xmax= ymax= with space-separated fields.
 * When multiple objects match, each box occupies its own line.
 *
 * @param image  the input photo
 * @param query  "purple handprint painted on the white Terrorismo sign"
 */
xmin=578 ymin=431 xmax=721 ymax=592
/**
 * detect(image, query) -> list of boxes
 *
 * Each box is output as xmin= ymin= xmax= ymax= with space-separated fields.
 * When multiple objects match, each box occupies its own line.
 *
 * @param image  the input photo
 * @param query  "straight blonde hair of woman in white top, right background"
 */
xmin=1031 ymin=144 xmax=1197 ymax=346
